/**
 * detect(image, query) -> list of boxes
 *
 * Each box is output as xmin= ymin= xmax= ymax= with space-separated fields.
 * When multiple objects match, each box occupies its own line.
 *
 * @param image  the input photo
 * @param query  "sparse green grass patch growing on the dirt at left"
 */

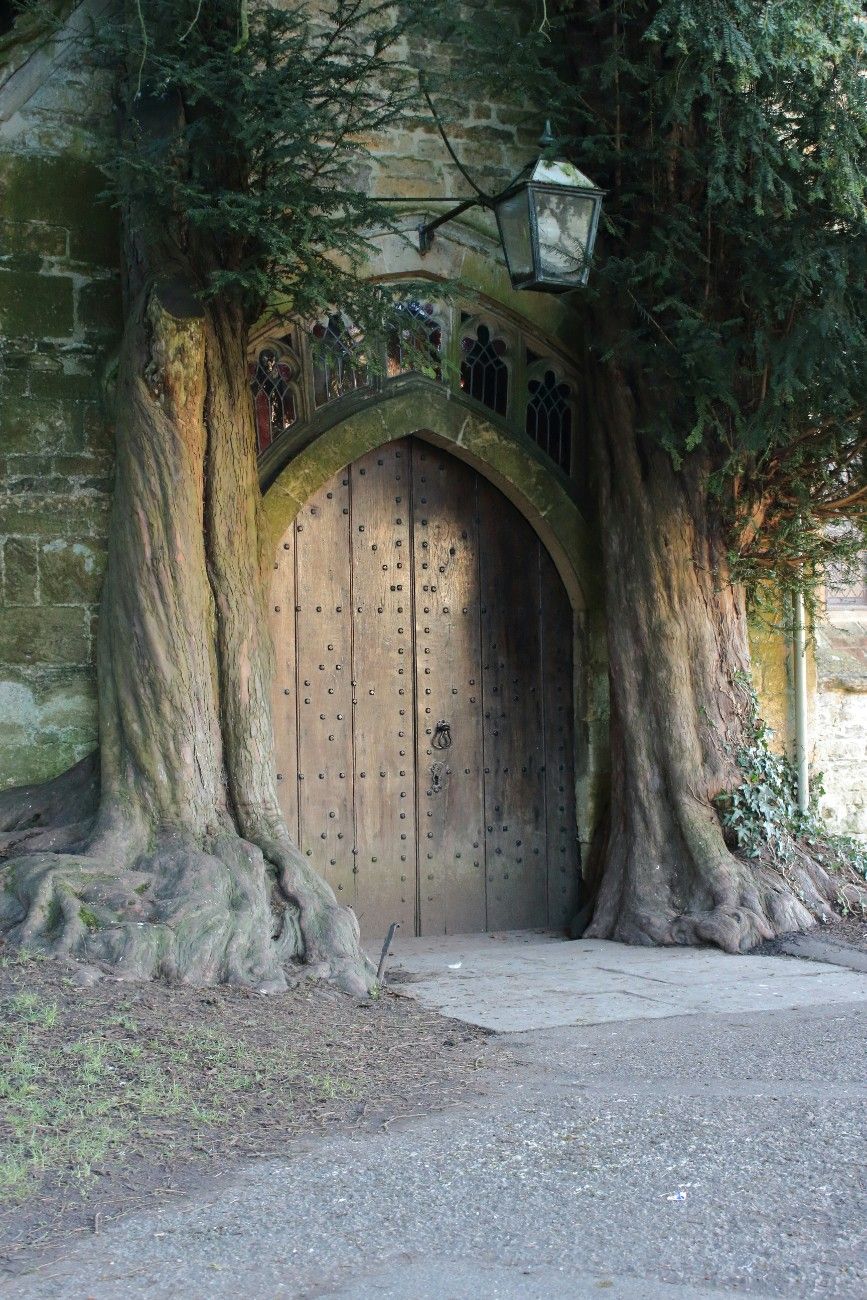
xmin=0 ymin=991 xmax=305 ymax=1201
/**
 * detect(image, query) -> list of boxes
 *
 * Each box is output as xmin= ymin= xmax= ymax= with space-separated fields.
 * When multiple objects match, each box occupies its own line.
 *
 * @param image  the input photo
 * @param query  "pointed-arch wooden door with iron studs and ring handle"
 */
xmin=272 ymin=438 xmax=578 ymax=940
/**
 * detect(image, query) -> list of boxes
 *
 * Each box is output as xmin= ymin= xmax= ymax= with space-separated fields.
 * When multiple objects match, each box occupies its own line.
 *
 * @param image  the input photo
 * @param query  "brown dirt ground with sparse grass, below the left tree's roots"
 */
xmin=0 ymin=945 xmax=494 ymax=1277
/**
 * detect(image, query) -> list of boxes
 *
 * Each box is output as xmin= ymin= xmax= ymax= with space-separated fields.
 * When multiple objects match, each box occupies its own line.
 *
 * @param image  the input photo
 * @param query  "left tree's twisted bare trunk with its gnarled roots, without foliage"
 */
xmin=0 ymin=269 xmax=373 ymax=996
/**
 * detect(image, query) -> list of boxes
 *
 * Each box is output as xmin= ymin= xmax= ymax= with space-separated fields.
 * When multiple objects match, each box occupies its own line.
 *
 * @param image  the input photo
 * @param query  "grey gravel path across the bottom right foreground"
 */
xmin=4 ymin=1004 xmax=867 ymax=1300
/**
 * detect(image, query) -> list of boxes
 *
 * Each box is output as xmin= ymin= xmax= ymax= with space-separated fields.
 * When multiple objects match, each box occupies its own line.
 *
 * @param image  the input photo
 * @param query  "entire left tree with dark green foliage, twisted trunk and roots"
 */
xmin=0 ymin=0 xmax=426 ymax=995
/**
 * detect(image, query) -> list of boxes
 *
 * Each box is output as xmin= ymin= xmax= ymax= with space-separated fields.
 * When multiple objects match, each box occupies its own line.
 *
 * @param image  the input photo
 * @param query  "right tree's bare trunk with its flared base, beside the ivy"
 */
xmin=585 ymin=351 xmax=836 ymax=952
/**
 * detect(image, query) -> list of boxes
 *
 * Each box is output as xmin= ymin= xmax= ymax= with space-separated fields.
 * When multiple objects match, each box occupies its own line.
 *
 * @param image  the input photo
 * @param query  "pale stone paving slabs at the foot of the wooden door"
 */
xmin=390 ymin=931 xmax=867 ymax=1034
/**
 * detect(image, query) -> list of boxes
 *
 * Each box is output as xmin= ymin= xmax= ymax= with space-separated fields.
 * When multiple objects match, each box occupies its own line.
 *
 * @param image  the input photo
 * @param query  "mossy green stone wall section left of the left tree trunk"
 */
xmin=0 ymin=153 xmax=120 ymax=785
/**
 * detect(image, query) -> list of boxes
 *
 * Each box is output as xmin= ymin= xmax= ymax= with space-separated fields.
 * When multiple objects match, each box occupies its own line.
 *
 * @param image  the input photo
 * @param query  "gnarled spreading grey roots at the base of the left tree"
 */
xmin=0 ymin=831 xmax=374 ymax=997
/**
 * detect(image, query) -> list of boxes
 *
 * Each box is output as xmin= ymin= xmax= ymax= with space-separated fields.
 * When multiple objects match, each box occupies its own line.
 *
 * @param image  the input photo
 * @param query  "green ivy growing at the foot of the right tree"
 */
xmin=715 ymin=686 xmax=867 ymax=913
